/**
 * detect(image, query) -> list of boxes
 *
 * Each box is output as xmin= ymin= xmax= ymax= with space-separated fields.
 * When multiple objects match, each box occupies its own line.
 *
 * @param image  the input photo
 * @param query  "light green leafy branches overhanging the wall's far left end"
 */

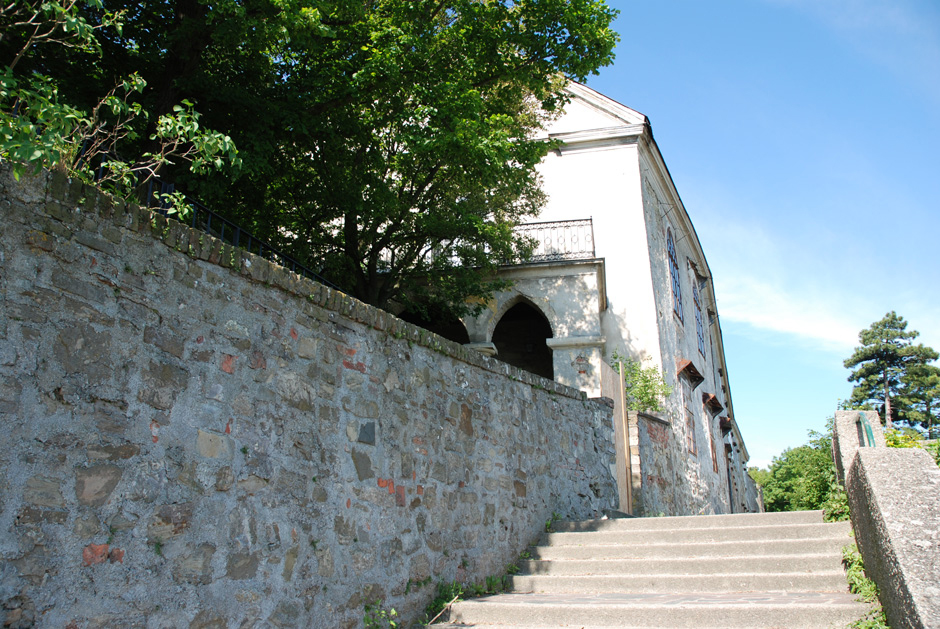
xmin=0 ymin=0 xmax=238 ymax=197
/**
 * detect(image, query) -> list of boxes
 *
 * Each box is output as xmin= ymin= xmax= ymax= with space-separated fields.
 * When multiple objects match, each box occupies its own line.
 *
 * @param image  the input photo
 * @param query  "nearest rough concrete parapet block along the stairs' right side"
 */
xmin=846 ymin=448 xmax=940 ymax=629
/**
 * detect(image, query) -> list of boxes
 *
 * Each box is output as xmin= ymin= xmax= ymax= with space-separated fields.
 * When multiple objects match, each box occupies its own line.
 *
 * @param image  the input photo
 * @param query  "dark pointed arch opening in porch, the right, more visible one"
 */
xmin=493 ymin=304 xmax=555 ymax=380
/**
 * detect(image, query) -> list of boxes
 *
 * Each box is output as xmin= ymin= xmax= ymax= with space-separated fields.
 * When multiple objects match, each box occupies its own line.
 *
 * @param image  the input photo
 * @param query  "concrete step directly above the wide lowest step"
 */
xmin=510 ymin=570 xmax=849 ymax=594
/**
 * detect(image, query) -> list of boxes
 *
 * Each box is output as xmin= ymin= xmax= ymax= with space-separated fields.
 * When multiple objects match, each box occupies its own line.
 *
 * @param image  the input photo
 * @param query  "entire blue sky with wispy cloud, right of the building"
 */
xmin=588 ymin=0 xmax=940 ymax=466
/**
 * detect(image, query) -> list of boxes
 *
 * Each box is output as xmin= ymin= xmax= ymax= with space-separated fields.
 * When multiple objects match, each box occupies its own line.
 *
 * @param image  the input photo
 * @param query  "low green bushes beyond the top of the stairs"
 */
xmin=748 ymin=419 xmax=848 ymax=521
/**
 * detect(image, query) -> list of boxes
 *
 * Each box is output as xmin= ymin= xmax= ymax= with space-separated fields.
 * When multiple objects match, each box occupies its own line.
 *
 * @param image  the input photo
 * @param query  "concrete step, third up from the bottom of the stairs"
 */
xmin=518 ymin=552 xmax=842 ymax=576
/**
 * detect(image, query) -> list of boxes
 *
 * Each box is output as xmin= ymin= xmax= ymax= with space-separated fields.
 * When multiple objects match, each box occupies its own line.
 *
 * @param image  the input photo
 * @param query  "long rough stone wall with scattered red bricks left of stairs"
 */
xmin=0 ymin=170 xmax=617 ymax=627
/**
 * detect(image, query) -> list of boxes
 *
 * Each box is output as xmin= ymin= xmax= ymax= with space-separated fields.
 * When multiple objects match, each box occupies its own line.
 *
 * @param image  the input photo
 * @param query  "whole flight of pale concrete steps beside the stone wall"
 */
xmin=435 ymin=511 xmax=868 ymax=629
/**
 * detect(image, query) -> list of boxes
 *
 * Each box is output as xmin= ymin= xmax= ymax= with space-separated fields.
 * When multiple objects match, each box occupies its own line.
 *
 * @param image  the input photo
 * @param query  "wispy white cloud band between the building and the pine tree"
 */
xmin=699 ymin=218 xmax=940 ymax=357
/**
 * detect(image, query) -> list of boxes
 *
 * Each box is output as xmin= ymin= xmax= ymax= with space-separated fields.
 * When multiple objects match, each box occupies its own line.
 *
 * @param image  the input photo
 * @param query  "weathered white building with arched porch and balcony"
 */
xmin=464 ymin=84 xmax=760 ymax=515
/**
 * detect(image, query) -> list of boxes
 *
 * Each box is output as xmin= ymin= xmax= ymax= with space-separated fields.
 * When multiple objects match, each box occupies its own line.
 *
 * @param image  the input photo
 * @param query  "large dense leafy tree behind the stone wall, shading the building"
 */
xmin=36 ymin=0 xmax=617 ymax=313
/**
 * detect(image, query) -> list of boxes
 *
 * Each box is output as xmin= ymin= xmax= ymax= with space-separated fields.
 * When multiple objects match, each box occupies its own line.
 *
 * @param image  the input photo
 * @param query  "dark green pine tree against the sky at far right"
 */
xmin=844 ymin=311 xmax=938 ymax=429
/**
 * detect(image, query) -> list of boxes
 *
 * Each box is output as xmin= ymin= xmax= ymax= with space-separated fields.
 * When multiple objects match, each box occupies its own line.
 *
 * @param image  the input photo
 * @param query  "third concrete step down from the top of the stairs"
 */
xmin=528 ymin=533 xmax=852 ymax=560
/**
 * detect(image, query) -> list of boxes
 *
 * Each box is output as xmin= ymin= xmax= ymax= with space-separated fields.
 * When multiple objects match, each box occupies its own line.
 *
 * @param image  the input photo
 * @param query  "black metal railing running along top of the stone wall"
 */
xmin=144 ymin=178 xmax=341 ymax=290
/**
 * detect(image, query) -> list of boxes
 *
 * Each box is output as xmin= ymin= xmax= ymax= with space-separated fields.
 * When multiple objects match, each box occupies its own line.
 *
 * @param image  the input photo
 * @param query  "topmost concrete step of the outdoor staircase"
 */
xmin=552 ymin=511 xmax=823 ymax=533
